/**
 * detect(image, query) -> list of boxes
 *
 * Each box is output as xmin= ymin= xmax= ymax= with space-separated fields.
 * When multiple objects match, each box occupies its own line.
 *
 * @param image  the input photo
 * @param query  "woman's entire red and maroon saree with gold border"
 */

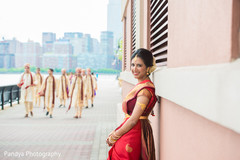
xmin=108 ymin=80 xmax=157 ymax=160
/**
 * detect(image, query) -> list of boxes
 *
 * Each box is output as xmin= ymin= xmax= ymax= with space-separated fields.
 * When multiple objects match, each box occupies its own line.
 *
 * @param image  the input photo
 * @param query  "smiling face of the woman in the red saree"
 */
xmin=131 ymin=56 xmax=147 ymax=80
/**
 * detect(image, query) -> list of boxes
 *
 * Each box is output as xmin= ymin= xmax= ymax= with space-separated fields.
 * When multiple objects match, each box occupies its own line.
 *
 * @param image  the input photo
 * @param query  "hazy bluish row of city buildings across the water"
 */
xmin=0 ymin=31 xmax=116 ymax=70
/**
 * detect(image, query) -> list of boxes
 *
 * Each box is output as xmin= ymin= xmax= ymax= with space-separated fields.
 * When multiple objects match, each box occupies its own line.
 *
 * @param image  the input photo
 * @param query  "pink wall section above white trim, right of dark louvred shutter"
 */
xmin=167 ymin=0 xmax=240 ymax=67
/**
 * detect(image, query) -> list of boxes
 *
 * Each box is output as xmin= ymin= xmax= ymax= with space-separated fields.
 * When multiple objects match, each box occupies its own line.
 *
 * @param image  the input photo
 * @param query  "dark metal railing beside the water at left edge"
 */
xmin=0 ymin=85 xmax=21 ymax=110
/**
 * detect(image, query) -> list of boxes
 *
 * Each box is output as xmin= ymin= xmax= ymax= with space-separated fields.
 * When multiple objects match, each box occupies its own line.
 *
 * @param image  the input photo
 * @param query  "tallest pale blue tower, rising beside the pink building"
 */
xmin=107 ymin=0 xmax=122 ymax=45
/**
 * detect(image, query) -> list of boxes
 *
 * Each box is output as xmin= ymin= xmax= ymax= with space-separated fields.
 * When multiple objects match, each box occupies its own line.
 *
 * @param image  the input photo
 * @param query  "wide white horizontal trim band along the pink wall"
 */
xmin=120 ymin=59 xmax=240 ymax=133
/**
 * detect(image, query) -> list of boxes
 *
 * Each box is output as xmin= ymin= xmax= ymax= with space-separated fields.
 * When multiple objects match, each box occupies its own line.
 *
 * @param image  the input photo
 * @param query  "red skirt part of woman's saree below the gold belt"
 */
xmin=108 ymin=118 xmax=156 ymax=160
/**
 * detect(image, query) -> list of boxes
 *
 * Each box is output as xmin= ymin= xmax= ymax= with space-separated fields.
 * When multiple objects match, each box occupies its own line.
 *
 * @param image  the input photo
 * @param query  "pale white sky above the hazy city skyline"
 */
xmin=0 ymin=0 xmax=108 ymax=43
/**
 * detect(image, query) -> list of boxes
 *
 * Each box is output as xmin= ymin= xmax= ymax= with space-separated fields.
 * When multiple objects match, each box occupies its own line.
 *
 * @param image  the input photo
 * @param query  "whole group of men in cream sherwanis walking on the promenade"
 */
xmin=18 ymin=64 xmax=97 ymax=118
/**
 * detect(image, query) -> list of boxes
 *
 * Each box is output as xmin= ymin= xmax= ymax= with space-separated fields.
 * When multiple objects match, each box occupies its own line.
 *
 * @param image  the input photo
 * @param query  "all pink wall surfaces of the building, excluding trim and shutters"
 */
xmin=122 ymin=0 xmax=240 ymax=160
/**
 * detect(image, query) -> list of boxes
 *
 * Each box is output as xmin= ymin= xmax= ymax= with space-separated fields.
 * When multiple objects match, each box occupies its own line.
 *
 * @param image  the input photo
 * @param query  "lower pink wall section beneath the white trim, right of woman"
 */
xmin=160 ymin=98 xmax=240 ymax=160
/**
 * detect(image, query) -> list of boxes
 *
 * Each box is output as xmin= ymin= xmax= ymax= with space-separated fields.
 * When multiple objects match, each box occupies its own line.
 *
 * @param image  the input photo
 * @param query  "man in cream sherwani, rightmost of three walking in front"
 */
xmin=68 ymin=68 xmax=84 ymax=118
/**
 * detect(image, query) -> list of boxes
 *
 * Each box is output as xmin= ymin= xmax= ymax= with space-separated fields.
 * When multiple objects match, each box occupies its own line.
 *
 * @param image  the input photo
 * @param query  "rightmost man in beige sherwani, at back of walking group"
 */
xmin=84 ymin=68 xmax=97 ymax=108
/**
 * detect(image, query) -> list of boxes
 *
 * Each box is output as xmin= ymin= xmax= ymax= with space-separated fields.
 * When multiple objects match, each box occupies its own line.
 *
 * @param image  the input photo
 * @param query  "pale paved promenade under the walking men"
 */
xmin=0 ymin=75 xmax=121 ymax=160
